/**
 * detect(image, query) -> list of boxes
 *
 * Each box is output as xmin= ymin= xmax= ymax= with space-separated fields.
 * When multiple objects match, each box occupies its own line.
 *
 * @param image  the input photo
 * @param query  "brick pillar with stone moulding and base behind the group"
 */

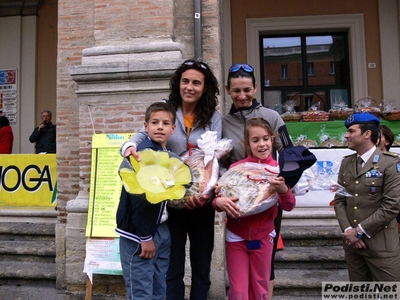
xmin=57 ymin=0 xmax=225 ymax=299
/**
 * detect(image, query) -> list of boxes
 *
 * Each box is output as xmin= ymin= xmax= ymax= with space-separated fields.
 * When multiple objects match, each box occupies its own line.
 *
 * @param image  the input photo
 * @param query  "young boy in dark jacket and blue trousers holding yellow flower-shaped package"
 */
xmin=116 ymin=102 xmax=176 ymax=300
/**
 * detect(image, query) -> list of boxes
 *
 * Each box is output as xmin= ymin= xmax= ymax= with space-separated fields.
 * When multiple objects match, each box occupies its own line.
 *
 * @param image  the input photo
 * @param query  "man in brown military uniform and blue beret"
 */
xmin=334 ymin=113 xmax=400 ymax=281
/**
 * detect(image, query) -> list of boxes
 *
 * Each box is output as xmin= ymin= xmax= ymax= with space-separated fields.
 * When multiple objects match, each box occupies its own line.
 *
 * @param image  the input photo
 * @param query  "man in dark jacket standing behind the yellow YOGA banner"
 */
xmin=29 ymin=110 xmax=57 ymax=153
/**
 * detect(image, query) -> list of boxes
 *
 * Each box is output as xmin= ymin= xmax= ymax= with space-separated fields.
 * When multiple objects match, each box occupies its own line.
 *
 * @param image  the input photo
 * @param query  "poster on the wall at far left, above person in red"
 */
xmin=0 ymin=69 xmax=18 ymax=125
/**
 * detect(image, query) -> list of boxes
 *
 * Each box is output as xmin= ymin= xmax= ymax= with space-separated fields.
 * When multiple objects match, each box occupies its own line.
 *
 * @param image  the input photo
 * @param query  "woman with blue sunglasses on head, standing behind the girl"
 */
xmin=222 ymin=64 xmax=293 ymax=299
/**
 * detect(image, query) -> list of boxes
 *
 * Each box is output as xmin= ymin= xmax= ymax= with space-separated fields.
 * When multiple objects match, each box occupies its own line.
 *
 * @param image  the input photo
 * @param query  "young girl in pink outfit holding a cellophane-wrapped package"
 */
xmin=212 ymin=118 xmax=296 ymax=300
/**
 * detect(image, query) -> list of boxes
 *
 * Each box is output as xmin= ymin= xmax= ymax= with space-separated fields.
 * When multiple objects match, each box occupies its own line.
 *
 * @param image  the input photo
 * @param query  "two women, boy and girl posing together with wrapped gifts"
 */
xmin=117 ymin=60 xmax=295 ymax=300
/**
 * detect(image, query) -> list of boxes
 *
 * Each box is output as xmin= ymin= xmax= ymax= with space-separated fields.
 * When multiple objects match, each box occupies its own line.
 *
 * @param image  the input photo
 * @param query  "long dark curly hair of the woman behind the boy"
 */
xmin=168 ymin=60 xmax=219 ymax=128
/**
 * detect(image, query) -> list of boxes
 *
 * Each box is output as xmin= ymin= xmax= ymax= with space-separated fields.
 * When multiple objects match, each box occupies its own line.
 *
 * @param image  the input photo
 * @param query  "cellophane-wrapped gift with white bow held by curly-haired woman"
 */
xmin=168 ymin=131 xmax=233 ymax=208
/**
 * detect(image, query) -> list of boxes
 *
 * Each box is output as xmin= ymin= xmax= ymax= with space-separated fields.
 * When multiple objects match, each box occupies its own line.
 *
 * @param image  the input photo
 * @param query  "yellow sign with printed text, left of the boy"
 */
xmin=86 ymin=133 xmax=132 ymax=237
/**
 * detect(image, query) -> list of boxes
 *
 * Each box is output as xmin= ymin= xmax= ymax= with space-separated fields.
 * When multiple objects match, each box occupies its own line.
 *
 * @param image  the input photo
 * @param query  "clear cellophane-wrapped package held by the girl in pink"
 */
xmin=218 ymin=162 xmax=279 ymax=216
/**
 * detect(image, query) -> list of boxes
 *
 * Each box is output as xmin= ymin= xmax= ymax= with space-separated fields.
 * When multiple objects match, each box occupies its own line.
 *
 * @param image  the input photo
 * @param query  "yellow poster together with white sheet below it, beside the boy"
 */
xmin=83 ymin=133 xmax=132 ymax=283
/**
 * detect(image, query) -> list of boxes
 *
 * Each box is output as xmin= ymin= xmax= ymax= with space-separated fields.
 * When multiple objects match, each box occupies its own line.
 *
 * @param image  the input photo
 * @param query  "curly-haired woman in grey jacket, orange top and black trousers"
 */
xmin=121 ymin=60 xmax=222 ymax=300
